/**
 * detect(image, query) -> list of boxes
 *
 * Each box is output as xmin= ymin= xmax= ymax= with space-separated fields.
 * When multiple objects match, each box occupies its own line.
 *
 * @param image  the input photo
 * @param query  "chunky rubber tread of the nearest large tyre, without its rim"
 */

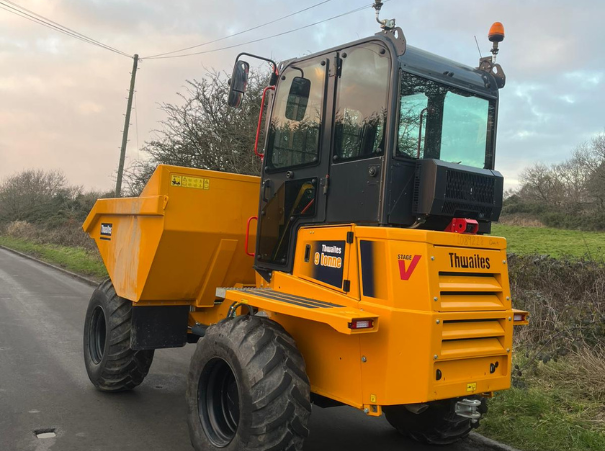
xmin=187 ymin=315 xmax=311 ymax=451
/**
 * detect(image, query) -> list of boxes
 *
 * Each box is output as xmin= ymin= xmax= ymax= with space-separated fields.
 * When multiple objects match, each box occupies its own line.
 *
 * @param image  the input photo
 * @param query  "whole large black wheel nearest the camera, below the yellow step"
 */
xmin=187 ymin=315 xmax=311 ymax=451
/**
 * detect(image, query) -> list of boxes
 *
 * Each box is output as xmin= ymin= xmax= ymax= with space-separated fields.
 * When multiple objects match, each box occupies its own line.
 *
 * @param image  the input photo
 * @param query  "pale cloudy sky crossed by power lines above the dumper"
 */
xmin=0 ymin=0 xmax=605 ymax=190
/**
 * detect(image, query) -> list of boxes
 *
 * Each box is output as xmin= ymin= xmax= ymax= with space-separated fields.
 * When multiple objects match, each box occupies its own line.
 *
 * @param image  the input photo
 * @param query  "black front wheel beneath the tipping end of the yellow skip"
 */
xmin=84 ymin=279 xmax=153 ymax=392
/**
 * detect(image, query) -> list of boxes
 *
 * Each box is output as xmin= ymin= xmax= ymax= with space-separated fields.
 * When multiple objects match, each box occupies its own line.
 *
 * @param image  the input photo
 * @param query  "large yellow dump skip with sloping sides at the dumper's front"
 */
xmin=83 ymin=165 xmax=260 ymax=306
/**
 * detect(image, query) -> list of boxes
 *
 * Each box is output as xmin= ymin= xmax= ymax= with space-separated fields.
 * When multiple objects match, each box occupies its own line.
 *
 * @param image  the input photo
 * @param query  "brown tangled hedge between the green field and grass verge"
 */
xmin=508 ymin=255 xmax=605 ymax=366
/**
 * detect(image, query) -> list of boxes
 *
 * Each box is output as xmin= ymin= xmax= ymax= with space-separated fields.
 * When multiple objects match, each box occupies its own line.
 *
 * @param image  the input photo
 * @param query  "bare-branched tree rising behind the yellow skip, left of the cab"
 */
xmin=126 ymin=72 xmax=268 ymax=195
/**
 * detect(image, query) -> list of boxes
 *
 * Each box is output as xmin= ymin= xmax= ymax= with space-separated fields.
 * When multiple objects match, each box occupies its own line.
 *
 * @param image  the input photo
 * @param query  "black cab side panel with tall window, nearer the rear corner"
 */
xmin=327 ymin=41 xmax=392 ymax=223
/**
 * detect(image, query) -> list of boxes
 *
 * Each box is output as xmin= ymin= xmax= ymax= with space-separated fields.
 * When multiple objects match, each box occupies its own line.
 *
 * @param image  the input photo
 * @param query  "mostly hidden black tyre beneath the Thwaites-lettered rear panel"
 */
xmin=383 ymin=397 xmax=487 ymax=445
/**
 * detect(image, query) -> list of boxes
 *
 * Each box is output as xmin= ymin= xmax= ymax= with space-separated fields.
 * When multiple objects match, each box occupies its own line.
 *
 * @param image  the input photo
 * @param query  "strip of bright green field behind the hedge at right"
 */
xmin=492 ymin=224 xmax=605 ymax=261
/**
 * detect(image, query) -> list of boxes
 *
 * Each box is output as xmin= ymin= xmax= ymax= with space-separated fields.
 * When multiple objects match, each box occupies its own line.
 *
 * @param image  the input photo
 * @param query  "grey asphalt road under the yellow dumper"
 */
xmin=0 ymin=249 xmax=500 ymax=451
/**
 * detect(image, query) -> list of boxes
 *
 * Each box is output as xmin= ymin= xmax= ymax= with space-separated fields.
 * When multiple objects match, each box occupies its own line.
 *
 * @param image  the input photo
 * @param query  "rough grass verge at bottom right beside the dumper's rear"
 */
xmin=477 ymin=353 xmax=605 ymax=451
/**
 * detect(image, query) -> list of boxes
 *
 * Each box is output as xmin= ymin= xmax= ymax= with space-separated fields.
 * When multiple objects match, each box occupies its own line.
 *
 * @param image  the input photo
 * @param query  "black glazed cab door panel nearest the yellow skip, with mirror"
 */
xmin=255 ymin=54 xmax=335 ymax=274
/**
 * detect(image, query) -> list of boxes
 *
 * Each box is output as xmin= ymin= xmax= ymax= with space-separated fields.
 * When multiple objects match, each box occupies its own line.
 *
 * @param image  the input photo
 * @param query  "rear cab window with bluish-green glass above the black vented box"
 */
xmin=397 ymin=73 xmax=495 ymax=169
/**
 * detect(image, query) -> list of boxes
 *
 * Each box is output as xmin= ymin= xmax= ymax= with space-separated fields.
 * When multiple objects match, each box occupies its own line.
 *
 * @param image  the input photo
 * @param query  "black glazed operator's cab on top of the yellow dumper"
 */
xmin=245 ymin=25 xmax=504 ymax=282
